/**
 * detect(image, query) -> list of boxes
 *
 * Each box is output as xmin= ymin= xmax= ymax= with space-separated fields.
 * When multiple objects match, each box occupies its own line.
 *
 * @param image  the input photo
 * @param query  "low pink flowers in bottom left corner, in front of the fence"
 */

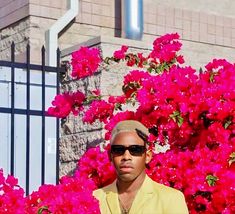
xmin=0 ymin=170 xmax=100 ymax=214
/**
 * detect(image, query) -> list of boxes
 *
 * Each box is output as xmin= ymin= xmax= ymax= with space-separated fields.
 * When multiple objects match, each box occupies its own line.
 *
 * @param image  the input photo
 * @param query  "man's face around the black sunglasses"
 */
xmin=110 ymin=132 xmax=151 ymax=182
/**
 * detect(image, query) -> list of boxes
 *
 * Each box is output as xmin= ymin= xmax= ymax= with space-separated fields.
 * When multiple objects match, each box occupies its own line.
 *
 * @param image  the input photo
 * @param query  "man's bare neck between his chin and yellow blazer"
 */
xmin=117 ymin=172 xmax=146 ymax=194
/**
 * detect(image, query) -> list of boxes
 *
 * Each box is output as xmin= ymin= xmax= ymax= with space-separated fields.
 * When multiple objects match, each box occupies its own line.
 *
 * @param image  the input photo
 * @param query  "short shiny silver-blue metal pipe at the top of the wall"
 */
xmin=122 ymin=0 xmax=144 ymax=40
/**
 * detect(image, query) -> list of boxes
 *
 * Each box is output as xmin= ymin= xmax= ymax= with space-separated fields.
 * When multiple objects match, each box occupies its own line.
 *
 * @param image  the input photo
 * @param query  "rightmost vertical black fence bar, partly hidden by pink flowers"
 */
xmin=56 ymin=48 xmax=60 ymax=184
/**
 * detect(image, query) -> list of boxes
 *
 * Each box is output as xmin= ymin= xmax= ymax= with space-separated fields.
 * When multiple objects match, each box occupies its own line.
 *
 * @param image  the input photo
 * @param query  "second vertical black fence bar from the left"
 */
xmin=25 ymin=44 xmax=30 ymax=195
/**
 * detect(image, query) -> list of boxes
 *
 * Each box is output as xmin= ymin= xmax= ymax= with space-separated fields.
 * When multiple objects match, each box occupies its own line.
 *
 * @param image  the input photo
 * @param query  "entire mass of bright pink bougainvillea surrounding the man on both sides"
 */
xmin=0 ymin=34 xmax=235 ymax=214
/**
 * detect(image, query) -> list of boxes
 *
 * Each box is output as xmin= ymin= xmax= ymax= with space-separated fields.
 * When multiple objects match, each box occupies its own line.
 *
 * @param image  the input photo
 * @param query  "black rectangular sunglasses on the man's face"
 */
xmin=111 ymin=145 xmax=146 ymax=156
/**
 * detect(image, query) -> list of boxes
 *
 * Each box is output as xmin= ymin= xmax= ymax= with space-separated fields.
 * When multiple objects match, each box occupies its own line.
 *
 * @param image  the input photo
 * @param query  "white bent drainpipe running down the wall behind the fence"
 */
xmin=45 ymin=0 xmax=79 ymax=66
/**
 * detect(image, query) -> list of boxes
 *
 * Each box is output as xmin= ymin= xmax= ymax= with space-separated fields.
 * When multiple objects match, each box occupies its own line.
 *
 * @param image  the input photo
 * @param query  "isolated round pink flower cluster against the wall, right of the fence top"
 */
xmin=71 ymin=47 xmax=101 ymax=79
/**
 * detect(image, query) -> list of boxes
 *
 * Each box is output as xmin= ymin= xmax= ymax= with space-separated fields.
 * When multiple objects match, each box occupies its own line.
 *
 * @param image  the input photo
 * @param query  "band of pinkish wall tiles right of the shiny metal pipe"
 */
xmin=145 ymin=1 xmax=235 ymax=47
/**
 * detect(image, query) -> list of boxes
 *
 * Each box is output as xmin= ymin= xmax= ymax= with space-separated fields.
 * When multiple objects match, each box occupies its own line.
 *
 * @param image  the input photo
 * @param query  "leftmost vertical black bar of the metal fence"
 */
xmin=10 ymin=42 xmax=15 ymax=175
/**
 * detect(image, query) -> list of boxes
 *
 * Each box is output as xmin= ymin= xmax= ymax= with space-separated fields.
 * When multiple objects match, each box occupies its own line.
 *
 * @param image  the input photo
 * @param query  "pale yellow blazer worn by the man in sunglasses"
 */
xmin=93 ymin=175 xmax=188 ymax=214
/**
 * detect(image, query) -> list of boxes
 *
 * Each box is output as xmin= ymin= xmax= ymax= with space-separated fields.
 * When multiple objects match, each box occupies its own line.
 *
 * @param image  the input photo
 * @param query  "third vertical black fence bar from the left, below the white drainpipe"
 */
xmin=41 ymin=46 xmax=45 ymax=185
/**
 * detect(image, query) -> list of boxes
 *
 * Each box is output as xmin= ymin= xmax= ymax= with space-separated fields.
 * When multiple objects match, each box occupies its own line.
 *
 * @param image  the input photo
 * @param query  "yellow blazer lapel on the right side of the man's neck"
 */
xmin=129 ymin=175 xmax=153 ymax=214
